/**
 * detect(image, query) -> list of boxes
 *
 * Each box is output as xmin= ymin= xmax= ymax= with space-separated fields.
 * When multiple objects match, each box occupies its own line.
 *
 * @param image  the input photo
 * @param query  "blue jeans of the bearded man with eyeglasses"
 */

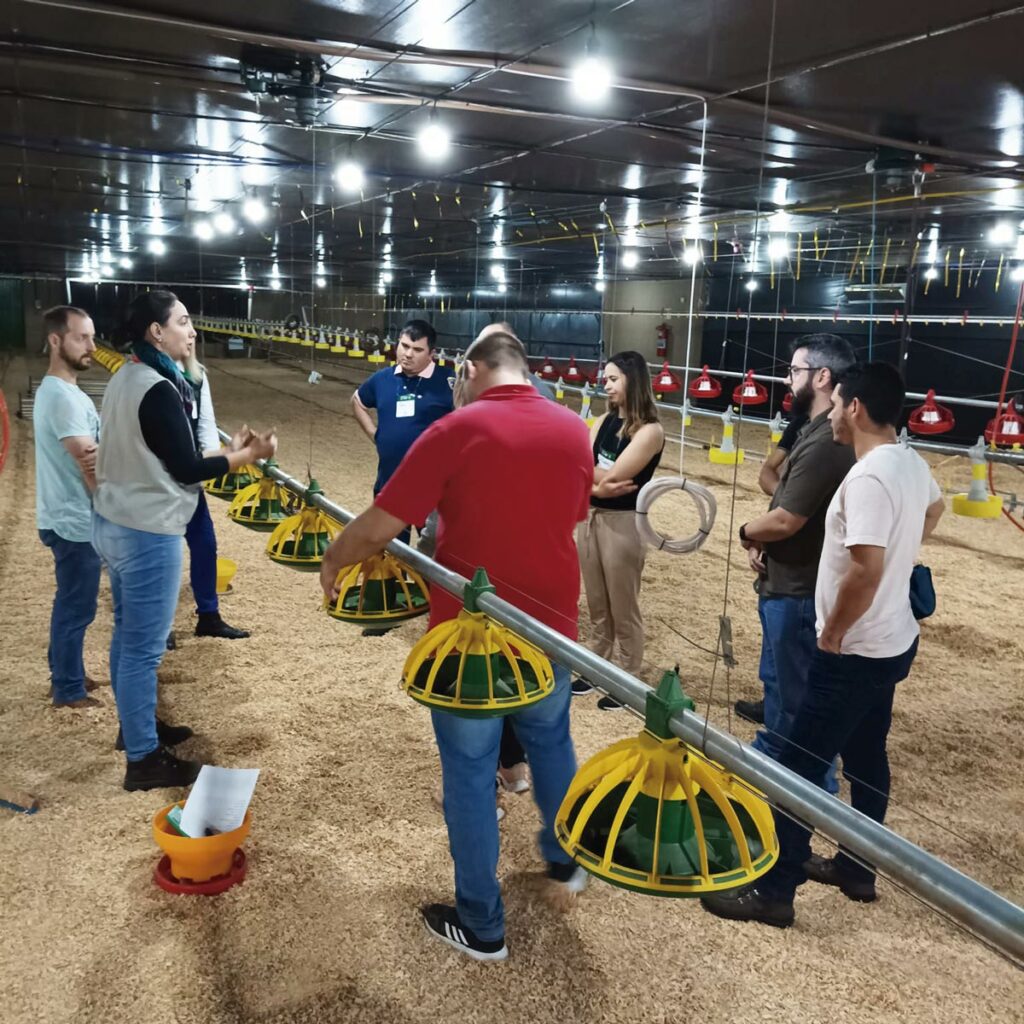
xmin=753 ymin=596 xmax=839 ymax=794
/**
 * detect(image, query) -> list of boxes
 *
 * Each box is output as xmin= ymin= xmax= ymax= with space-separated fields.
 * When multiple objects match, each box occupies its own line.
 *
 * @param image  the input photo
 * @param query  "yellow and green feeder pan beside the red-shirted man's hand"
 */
xmin=324 ymin=551 xmax=430 ymax=626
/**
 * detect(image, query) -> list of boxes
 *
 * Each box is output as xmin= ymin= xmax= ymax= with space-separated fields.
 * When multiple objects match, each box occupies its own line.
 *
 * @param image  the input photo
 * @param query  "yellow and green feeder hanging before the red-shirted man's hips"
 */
xmin=402 ymin=568 xmax=555 ymax=718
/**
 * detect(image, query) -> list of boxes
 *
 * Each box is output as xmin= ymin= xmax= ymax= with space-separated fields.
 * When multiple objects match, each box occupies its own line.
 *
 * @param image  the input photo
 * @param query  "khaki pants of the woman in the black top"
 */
xmin=577 ymin=509 xmax=647 ymax=676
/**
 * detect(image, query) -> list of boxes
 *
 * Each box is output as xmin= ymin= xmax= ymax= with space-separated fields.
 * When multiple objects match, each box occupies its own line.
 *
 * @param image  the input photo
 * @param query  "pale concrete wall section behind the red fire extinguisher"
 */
xmin=603 ymin=274 xmax=703 ymax=366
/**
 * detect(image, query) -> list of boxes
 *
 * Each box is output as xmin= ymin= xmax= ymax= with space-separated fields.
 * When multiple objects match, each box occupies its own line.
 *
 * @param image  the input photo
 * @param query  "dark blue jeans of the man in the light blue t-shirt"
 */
xmin=39 ymin=529 xmax=99 ymax=703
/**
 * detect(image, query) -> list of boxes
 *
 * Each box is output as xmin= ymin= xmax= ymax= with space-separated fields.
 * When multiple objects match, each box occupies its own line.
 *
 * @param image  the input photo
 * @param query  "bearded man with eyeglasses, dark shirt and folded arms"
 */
xmin=739 ymin=334 xmax=855 ymax=794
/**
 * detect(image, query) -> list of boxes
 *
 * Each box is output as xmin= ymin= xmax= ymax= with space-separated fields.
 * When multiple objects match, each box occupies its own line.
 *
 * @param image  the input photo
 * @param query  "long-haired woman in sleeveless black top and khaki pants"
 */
xmin=572 ymin=352 xmax=665 ymax=711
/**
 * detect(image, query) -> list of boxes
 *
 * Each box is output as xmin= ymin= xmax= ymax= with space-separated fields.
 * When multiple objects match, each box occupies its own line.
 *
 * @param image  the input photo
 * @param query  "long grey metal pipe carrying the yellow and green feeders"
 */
xmin=232 ymin=444 xmax=1024 ymax=964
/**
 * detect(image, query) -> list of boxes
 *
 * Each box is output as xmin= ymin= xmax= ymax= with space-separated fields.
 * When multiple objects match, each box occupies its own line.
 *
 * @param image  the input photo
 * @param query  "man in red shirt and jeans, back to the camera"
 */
xmin=321 ymin=332 xmax=594 ymax=961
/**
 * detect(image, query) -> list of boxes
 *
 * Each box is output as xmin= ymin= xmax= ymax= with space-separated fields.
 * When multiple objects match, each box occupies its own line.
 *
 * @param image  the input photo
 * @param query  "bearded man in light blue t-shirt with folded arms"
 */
xmin=32 ymin=306 xmax=99 ymax=708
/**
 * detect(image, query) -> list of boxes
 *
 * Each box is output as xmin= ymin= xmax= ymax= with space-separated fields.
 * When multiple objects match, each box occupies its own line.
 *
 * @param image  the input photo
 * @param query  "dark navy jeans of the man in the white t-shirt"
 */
xmin=758 ymin=640 xmax=918 ymax=902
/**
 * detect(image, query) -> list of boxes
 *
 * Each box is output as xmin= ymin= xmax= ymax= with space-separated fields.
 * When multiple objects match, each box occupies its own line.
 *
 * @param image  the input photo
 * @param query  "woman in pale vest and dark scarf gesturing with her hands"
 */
xmin=92 ymin=291 xmax=278 ymax=790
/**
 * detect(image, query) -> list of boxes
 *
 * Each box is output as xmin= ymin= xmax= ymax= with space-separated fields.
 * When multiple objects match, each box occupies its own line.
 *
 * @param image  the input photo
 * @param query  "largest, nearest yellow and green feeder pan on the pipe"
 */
xmin=555 ymin=672 xmax=778 ymax=896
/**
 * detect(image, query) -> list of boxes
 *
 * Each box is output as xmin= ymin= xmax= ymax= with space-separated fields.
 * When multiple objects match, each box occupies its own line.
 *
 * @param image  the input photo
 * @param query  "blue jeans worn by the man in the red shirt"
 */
xmin=431 ymin=665 xmax=577 ymax=941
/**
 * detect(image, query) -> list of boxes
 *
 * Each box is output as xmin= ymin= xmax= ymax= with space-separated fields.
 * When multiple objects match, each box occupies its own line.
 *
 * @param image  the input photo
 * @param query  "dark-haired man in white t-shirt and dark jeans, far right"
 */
xmin=702 ymin=362 xmax=943 ymax=928
